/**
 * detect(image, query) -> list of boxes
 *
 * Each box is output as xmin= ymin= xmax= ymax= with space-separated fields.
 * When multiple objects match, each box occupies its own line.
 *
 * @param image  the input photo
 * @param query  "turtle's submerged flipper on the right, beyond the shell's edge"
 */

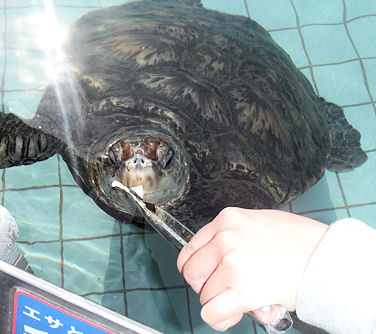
xmin=321 ymin=99 xmax=367 ymax=172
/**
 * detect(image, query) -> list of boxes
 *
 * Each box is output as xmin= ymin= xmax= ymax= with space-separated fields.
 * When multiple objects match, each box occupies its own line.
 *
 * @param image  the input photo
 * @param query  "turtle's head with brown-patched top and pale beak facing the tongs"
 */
xmin=105 ymin=134 xmax=188 ymax=205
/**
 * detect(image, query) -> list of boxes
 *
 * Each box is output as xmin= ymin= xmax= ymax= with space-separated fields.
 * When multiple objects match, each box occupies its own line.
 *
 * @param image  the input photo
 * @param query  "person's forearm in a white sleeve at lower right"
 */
xmin=297 ymin=219 xmax=376 ymax=334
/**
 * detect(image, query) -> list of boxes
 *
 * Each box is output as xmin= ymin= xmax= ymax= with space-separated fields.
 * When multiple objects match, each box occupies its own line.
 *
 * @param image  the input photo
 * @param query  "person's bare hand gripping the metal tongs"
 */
xmin=177 ymin=208 xmax=328 ymax=331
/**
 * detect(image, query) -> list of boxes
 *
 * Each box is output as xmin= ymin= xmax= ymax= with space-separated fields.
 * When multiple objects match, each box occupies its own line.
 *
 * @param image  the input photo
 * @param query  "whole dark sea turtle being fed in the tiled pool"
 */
xmin=0 ymin=0 xmax=367 ymax=231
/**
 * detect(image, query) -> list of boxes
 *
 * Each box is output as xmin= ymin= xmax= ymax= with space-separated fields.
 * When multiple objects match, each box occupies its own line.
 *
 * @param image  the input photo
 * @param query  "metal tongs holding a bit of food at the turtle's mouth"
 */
xmin=112 ymin=181 xmax=293 ymax=334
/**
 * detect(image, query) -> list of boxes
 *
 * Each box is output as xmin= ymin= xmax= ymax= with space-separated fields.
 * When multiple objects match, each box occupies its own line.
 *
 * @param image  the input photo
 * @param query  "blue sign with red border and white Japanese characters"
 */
xmin=12 ymin=290 xmax=113 ymax=334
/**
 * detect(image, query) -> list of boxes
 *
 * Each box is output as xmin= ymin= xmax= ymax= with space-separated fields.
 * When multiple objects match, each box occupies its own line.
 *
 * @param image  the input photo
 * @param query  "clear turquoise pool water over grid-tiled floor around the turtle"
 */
xmin=0 ymin=0 xmax=376 ymax=334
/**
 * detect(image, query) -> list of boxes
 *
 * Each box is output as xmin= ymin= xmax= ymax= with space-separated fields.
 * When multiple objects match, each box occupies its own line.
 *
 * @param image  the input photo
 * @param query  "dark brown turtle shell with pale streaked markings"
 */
xmin=33 ymin=1 xmax=330 ymax=230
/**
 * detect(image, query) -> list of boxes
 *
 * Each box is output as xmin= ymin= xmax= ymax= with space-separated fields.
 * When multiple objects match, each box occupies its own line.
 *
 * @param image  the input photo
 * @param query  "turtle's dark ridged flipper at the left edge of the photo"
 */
xmin=0 ymin=113 xmax=62 ymax=168
